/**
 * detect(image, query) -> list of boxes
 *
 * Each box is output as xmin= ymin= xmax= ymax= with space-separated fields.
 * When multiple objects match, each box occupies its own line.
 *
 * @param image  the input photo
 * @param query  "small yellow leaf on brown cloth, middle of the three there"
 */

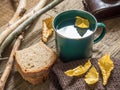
xmin=84 ymin=66 xmax=99 ymax=85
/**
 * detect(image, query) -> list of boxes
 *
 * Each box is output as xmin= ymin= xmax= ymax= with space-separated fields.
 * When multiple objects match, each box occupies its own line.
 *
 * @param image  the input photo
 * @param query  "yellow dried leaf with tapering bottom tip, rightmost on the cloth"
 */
xmin=98 ymin=54 xmax=114 ymax=85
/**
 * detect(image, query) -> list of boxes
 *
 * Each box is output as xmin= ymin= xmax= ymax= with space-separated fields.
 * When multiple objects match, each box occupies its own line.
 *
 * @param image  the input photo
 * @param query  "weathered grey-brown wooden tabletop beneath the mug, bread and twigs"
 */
xmin=0 ymin=0 xmax=120 ymax=90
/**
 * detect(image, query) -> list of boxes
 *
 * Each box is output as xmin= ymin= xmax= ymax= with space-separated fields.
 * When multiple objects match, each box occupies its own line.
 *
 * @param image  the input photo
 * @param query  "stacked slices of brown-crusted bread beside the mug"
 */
xmin=15 ymin=42 xmax=57 ymax=84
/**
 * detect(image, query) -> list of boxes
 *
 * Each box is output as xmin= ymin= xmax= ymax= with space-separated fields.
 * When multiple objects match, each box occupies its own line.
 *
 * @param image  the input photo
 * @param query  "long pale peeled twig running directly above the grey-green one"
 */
xmin=0 ymin=0 xmax=49 ymax=45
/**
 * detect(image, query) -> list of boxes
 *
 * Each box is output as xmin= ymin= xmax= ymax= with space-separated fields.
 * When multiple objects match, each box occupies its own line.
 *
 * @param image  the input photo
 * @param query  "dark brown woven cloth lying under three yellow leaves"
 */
xmin=49 ymin=58 xmax=120 ymax=90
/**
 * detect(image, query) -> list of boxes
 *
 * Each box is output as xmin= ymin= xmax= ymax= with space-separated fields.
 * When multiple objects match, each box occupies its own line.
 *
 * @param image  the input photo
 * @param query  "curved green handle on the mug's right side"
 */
xmin=94 ymin=23 xmax=106 ymax=44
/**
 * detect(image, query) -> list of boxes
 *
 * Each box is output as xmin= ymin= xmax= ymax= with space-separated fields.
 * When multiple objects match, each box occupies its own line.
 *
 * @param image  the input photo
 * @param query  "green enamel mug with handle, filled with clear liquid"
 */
xmin=53 ymin=10 xmax=106 ymax=62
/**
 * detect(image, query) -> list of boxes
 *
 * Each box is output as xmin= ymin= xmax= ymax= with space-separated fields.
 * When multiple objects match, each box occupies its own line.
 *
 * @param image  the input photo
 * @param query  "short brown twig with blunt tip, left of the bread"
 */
xmin=0 ymin=35 xmax=23 ymax=90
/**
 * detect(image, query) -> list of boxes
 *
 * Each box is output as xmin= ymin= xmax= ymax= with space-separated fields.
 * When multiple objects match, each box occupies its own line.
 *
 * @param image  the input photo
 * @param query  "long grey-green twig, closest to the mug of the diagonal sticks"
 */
xmin=0 ymin=0 xmax=63 ymax=55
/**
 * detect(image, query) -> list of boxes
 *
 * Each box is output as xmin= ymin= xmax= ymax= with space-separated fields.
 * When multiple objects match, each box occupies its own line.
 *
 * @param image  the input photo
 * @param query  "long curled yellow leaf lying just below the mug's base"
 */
xmin=64 ymin=60 xmax=91 ymax=76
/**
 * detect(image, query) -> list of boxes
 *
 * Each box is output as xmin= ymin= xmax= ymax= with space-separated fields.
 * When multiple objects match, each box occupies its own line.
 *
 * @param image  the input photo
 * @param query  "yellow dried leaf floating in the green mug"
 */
xmin=75 ymin=16 xmax=89 ymax=28
